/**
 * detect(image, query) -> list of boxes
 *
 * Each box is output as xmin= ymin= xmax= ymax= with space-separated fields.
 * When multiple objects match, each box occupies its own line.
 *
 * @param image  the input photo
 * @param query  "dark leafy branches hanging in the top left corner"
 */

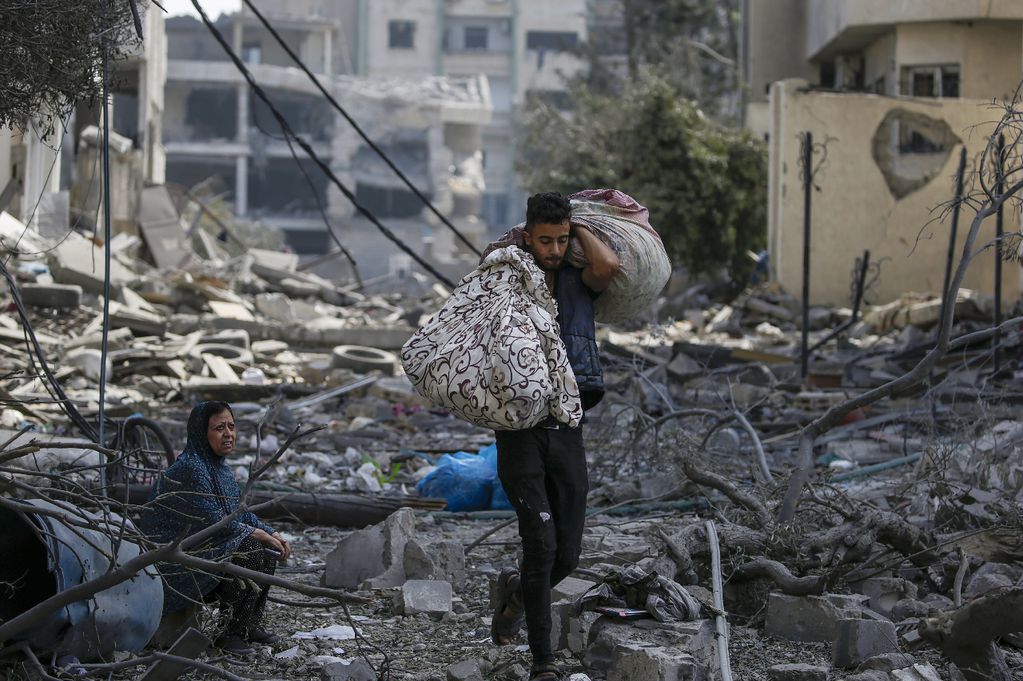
xmin=0 ymin=0 xmax=147 ymax=128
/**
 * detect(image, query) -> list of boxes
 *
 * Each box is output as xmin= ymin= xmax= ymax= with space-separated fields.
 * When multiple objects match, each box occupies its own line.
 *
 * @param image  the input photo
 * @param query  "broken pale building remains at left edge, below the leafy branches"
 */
xmin=0 ymin=5 xmax=167 ymax=237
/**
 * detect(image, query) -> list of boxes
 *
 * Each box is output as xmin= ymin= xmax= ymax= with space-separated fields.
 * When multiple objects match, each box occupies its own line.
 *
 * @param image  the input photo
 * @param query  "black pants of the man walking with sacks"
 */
xmin=496 ymin=426 xmax=589 ymax=662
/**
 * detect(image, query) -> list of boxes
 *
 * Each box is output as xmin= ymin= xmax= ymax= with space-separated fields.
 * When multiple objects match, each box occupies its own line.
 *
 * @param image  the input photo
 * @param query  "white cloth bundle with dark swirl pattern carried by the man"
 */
xmin=401 ymin=246 xmax=582 ymax=430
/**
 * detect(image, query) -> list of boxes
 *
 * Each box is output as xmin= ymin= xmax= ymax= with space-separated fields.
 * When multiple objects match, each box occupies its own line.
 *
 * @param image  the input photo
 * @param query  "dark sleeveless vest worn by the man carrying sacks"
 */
xmin=554 ymin=267 xmax=604 ymax=409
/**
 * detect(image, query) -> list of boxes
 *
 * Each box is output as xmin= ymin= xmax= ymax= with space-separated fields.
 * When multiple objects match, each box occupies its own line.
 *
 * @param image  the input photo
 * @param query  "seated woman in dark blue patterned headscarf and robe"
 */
xmin=139 ymin=402 xmax=291 ymax=653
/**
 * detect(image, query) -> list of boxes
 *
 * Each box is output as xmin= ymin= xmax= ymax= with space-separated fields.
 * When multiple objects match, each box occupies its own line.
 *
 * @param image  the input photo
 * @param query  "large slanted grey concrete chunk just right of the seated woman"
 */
xmin=322 ymin=508 xmax=415 ymax=589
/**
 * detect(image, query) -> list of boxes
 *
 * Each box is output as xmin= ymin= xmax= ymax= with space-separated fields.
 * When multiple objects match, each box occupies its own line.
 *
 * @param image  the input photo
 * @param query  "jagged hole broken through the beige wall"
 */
xmin=874 ymin=108 xmax=961 ymax=198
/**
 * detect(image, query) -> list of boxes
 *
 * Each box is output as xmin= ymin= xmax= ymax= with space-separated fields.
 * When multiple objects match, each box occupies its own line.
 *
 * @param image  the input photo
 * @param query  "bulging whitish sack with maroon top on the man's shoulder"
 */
xmin=483 ymin=189 xmax=671 ymax=323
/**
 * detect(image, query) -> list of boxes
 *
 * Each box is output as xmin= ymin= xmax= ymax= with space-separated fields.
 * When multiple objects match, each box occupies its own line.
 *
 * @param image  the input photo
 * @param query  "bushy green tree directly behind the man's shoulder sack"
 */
xmin=519 ymin=77 xmax=767 ymax=285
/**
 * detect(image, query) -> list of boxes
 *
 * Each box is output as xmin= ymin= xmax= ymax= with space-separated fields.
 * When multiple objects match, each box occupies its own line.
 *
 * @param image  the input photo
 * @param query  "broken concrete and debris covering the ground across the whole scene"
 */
xmin=0 ymin=190 xmax=1023 ymax=681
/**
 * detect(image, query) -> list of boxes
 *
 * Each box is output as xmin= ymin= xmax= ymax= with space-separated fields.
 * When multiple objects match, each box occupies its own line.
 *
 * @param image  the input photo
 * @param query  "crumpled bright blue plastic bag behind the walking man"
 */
xmin=415 ymin=444 xmax=512 ymax=511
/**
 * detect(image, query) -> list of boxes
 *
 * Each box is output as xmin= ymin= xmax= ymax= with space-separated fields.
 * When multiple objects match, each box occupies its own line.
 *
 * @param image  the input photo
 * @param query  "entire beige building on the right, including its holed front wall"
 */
xmin=743 ymin=0 xmax=1023 ymax=306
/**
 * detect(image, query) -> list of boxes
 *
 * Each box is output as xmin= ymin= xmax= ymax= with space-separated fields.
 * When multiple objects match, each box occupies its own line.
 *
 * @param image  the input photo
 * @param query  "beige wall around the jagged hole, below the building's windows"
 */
xmin=768 ymin=76 xmax=1021 ymax=305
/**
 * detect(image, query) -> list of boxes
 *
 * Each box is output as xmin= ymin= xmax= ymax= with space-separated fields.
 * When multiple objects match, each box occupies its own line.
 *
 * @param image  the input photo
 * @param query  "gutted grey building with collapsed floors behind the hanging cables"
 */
xmin=165 ymin=3 xmax=491 ymax=276
